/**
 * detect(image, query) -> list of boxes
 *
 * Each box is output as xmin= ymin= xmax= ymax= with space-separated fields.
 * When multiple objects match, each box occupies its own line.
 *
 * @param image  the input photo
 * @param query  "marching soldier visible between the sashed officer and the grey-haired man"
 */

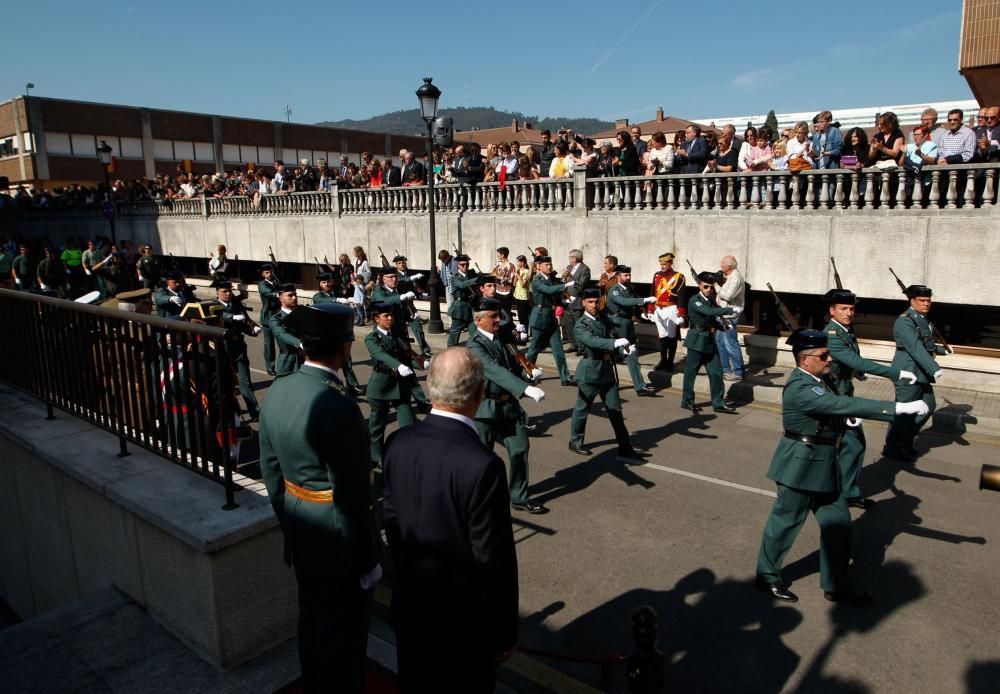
xmin=365 ymin=303 xmax=427 ymax=467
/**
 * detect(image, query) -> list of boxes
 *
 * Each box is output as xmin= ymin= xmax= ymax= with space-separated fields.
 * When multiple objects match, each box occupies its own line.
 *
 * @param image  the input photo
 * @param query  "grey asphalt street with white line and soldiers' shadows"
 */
xmin=241 ymin=331 xmax=1000 ymax=692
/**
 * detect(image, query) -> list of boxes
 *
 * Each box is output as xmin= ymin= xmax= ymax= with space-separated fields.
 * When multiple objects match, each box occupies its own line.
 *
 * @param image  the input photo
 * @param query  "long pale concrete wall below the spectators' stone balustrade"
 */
xmin=9 ymin=208 xmax=1000 ymax=306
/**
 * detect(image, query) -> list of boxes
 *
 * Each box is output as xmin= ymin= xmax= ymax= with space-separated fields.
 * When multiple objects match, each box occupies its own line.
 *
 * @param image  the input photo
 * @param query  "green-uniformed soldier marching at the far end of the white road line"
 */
xmin=569 ymin=287 xmax=642 ymax=461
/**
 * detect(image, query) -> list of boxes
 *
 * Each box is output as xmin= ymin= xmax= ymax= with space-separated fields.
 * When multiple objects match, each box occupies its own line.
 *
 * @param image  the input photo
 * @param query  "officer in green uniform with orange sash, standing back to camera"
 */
xmin=260 ymin=304 xmax=382 ymax=693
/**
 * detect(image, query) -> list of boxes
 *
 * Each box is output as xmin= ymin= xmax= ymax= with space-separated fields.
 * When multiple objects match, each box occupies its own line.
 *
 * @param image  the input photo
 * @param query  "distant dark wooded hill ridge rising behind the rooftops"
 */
xmin=316 ymin=106 xmax=615 ymax=135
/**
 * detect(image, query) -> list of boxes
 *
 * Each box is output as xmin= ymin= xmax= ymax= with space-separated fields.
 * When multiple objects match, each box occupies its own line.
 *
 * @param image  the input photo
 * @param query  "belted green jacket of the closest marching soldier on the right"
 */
xmin=767 ymin=368 xmax=896 ymax=492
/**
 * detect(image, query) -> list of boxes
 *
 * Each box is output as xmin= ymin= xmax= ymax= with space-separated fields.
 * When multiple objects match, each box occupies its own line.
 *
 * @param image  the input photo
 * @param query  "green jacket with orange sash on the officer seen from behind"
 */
xmin=260 ymin=366 xmax=378 ymax=578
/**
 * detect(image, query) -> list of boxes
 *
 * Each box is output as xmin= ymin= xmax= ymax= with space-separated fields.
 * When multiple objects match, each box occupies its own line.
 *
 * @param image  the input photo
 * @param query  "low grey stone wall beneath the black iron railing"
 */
xmin=0 ymin=388 xmax=298 ymax=670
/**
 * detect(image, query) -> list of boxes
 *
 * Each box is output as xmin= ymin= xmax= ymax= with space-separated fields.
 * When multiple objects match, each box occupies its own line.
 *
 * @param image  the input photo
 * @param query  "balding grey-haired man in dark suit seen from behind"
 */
xmin=383 ymin=347 xmax=518 ymax=694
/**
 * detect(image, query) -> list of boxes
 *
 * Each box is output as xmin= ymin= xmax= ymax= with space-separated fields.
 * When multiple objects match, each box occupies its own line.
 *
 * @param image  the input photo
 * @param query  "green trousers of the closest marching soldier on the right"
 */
xmin=757 ymin=483 xmax=851 ymax=592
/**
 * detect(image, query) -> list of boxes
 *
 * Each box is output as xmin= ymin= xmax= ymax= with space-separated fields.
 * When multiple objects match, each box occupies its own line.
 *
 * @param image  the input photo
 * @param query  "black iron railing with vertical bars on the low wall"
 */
xmin=0 ymin=289 xmax=245 ymax=508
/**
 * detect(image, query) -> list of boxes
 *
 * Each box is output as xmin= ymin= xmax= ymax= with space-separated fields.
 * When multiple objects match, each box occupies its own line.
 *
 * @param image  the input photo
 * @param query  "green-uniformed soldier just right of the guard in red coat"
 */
xmin=681 ymin=272 xmax=739 ymax=414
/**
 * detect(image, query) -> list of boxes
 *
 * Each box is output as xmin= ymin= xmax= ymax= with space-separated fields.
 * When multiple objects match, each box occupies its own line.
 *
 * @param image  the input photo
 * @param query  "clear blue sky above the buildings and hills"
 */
xmin=0 ymin=0 xmax=972 ymax=123
